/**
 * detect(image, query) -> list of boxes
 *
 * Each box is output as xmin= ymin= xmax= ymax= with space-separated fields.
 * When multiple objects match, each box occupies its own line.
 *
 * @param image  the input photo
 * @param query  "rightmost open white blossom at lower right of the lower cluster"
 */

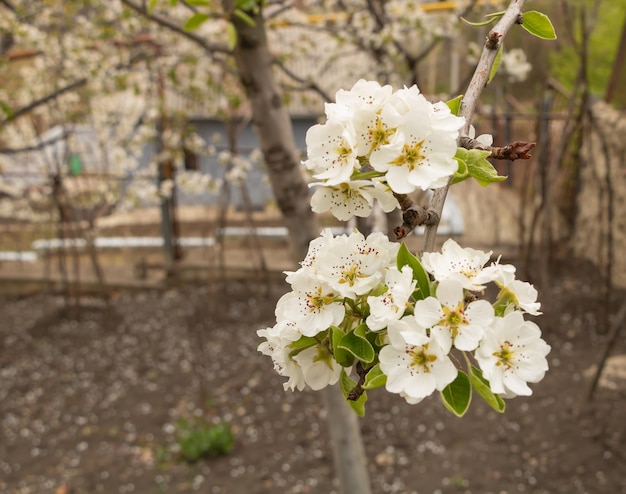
xmin=475 ymin=311 xmax=550 ymax=398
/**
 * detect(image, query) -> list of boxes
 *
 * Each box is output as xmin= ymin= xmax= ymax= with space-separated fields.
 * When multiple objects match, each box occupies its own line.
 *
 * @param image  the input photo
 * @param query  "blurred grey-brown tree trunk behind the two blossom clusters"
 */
xmin=223 ymin=0 xmax=371 ymax=494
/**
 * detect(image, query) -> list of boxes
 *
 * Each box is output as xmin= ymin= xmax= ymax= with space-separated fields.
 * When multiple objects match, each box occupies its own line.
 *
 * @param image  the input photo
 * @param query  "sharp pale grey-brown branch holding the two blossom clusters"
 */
xmin=423 ymin=0 xmax=525 ymax=252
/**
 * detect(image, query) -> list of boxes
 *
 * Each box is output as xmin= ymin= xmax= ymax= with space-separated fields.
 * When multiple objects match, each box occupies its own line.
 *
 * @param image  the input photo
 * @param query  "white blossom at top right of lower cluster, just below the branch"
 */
xmin=422 ymin=238 xmax=494 ymax=290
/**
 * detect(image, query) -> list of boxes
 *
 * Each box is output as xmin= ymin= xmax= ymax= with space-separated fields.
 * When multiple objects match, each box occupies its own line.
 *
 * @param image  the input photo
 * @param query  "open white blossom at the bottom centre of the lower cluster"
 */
xmin=379 ymin=316 xmax=458 ymax=404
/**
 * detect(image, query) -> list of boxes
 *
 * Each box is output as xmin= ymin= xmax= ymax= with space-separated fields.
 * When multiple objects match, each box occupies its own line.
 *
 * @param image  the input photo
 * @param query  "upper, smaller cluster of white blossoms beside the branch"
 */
xmin=304 ymin=80 xmax=465 ymax=220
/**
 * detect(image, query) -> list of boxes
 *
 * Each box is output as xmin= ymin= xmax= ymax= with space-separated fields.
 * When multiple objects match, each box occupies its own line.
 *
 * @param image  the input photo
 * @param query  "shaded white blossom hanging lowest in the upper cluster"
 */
xmin=311 ymin=180 xmax=398 ymax=221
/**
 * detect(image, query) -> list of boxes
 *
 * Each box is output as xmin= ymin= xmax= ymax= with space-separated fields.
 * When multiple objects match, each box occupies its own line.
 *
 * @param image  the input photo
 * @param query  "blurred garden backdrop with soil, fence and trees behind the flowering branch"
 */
xmin=0 ymin=0 xmax=626 ymax=494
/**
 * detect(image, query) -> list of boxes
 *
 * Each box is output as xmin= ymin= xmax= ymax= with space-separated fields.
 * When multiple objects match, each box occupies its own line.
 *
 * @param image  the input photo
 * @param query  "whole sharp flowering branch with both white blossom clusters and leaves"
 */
xmin=258 ymin=1 xmax=554 ymax=416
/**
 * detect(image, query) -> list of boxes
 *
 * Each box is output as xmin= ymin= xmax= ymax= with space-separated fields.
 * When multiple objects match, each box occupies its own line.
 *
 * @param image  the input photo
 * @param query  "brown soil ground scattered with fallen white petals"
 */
xmin=0 ymin=255 xmax=626 ymax=494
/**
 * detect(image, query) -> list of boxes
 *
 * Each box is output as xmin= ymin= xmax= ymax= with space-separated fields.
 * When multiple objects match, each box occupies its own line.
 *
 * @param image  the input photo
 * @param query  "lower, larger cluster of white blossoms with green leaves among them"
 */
xmin=258 ymin=230 xmax=550 ymax=410
